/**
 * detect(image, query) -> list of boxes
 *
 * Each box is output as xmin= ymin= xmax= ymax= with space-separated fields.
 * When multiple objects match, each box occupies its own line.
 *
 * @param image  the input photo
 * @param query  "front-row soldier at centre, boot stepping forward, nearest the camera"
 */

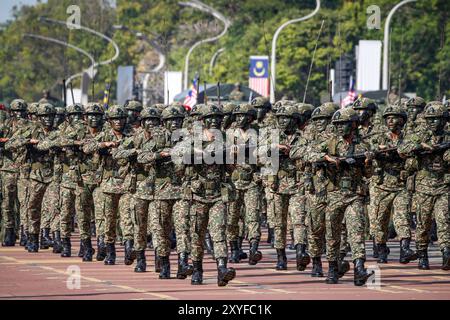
xmin=189 ymin=104 xmax=236 ymax=286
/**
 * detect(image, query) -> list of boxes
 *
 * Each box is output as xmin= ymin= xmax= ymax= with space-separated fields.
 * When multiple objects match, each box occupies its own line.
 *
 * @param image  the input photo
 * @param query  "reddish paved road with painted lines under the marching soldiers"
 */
xmin=0 ymin=231 xmax=450 ymax=300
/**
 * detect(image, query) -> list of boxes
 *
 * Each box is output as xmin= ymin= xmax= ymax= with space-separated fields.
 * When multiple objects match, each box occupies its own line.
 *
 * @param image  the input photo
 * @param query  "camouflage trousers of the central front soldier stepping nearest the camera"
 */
xmin=190 ymin=201 xmax=227 ymax=261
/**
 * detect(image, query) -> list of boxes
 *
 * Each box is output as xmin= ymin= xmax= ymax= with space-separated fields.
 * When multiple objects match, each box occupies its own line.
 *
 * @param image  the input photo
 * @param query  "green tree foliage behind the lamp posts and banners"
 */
xmin=0 ymin=0 xmax=450 ymax=104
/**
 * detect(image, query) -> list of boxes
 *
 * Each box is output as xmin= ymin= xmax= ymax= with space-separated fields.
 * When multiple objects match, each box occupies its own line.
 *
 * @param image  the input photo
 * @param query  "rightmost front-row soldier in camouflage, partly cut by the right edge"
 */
xmin=399 ymin=102 xmax=450 ymax=270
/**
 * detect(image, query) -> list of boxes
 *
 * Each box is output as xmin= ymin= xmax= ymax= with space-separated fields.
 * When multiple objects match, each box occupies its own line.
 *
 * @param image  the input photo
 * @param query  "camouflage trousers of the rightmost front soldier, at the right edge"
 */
xmin=416 ymin=187 xmax=450 ymax=250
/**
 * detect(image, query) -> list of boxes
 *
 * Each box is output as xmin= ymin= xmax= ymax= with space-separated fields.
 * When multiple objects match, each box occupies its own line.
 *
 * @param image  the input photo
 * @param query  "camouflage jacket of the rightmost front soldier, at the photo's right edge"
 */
xmin=399 ymin=131 xmax=450 ymax=195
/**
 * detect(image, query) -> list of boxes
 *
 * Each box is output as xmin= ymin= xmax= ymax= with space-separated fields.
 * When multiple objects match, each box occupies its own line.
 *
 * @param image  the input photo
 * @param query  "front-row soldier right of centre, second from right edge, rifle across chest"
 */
xmin=311 ymin=108 xmax=369 ymax=286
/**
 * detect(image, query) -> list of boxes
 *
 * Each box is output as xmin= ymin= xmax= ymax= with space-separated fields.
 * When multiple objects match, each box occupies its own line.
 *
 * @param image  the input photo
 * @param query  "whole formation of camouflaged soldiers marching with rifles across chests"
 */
xmin=0 ymin=97 xmax=450 ymax=286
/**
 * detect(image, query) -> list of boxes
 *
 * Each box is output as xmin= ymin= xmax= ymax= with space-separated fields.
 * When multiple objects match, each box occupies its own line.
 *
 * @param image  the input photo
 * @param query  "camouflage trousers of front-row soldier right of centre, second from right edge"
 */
xmin=325 ymin=191 xmax=366 ymax=261
